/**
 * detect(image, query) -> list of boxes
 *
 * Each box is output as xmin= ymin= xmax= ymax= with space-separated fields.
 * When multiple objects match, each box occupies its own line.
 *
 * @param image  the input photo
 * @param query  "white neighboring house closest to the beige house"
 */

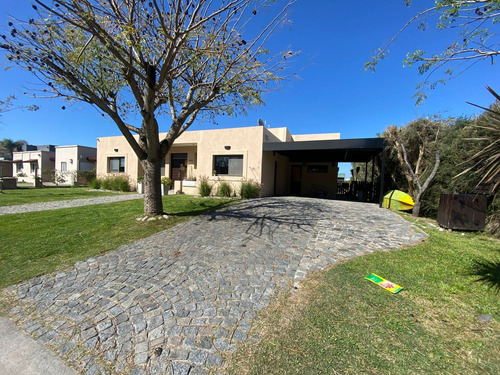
xmin=55 ymin=145 xmax=97 ymax=185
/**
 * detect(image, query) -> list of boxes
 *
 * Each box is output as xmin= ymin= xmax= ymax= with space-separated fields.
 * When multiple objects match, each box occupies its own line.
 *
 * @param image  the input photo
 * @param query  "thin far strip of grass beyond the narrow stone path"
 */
xmin=0 ymin=186 xmax=120 ymax=206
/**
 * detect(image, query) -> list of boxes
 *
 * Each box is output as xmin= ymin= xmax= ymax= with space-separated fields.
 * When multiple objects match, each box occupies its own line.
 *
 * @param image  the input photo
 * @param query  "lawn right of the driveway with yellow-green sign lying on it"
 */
xmin=229 ymin=217 xmax=500 ymax=375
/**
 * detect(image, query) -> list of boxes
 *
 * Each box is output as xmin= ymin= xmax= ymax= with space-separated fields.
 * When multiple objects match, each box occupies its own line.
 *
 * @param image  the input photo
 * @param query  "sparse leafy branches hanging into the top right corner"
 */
xmin=365 ymin=0 xmax=500 ymax=104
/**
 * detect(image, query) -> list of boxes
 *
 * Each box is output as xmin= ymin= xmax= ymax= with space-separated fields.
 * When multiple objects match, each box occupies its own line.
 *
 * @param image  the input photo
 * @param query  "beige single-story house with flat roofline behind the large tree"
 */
xmin=97 ymin=126 xmax=384 ymax=201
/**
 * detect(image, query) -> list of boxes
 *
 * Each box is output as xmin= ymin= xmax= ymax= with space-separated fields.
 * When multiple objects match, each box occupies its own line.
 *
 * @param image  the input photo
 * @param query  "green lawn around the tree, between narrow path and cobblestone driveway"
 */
xmin=0 ymin=195 xmax=232 ymax=288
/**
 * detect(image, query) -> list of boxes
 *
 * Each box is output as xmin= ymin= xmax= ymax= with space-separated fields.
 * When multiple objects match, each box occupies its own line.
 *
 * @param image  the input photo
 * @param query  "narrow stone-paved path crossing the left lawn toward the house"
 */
xmin=0 ymin=193 xmax=144 ymax=215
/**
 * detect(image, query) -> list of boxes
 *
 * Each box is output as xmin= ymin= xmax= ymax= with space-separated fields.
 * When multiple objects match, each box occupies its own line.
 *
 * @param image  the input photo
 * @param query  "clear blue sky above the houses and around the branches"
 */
xmin=0 ymin=0 xmax=499 ymax=176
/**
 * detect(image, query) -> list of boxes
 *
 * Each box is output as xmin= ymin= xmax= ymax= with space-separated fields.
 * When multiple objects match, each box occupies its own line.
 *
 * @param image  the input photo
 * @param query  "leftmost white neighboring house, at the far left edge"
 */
xmin=12 ymin=145 xmax=55 ymax=183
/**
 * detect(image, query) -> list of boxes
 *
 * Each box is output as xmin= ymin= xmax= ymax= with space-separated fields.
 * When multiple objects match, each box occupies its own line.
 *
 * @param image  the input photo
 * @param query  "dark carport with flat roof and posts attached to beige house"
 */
xmin=263 ymin=138 xmax=385 ymax=205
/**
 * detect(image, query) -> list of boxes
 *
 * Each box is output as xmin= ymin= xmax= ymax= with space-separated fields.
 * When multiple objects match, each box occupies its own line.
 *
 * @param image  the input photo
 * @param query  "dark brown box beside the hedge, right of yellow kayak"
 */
xmin=437 ymin=194 xmax=487 ymax=231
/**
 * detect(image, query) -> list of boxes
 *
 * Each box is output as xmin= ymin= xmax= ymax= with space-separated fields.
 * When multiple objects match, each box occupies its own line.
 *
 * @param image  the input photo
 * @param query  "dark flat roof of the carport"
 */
xmin=263 ymin=138 xmax=385 ymax=162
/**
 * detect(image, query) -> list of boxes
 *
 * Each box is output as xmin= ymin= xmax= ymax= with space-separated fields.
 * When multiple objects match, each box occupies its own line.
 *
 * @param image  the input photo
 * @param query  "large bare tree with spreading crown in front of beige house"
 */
xmin=1 ymin=0 xmax=295 ymax=215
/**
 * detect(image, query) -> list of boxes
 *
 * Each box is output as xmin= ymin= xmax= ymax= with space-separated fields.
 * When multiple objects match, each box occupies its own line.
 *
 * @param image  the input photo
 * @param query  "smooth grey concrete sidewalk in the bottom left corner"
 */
xmin=0 ymin=318 xmax=78 ymax=375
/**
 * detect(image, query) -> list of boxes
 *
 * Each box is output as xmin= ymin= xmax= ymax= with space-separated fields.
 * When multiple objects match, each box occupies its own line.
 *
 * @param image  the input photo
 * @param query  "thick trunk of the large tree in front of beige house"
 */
xmin=141 ymin=159 xmax=163 ymax=216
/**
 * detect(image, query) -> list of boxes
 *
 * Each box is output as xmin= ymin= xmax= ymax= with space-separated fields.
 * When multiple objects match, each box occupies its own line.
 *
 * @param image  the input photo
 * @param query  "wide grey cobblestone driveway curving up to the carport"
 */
xmin=3 ymin=197 xmax=425 ymax=375
